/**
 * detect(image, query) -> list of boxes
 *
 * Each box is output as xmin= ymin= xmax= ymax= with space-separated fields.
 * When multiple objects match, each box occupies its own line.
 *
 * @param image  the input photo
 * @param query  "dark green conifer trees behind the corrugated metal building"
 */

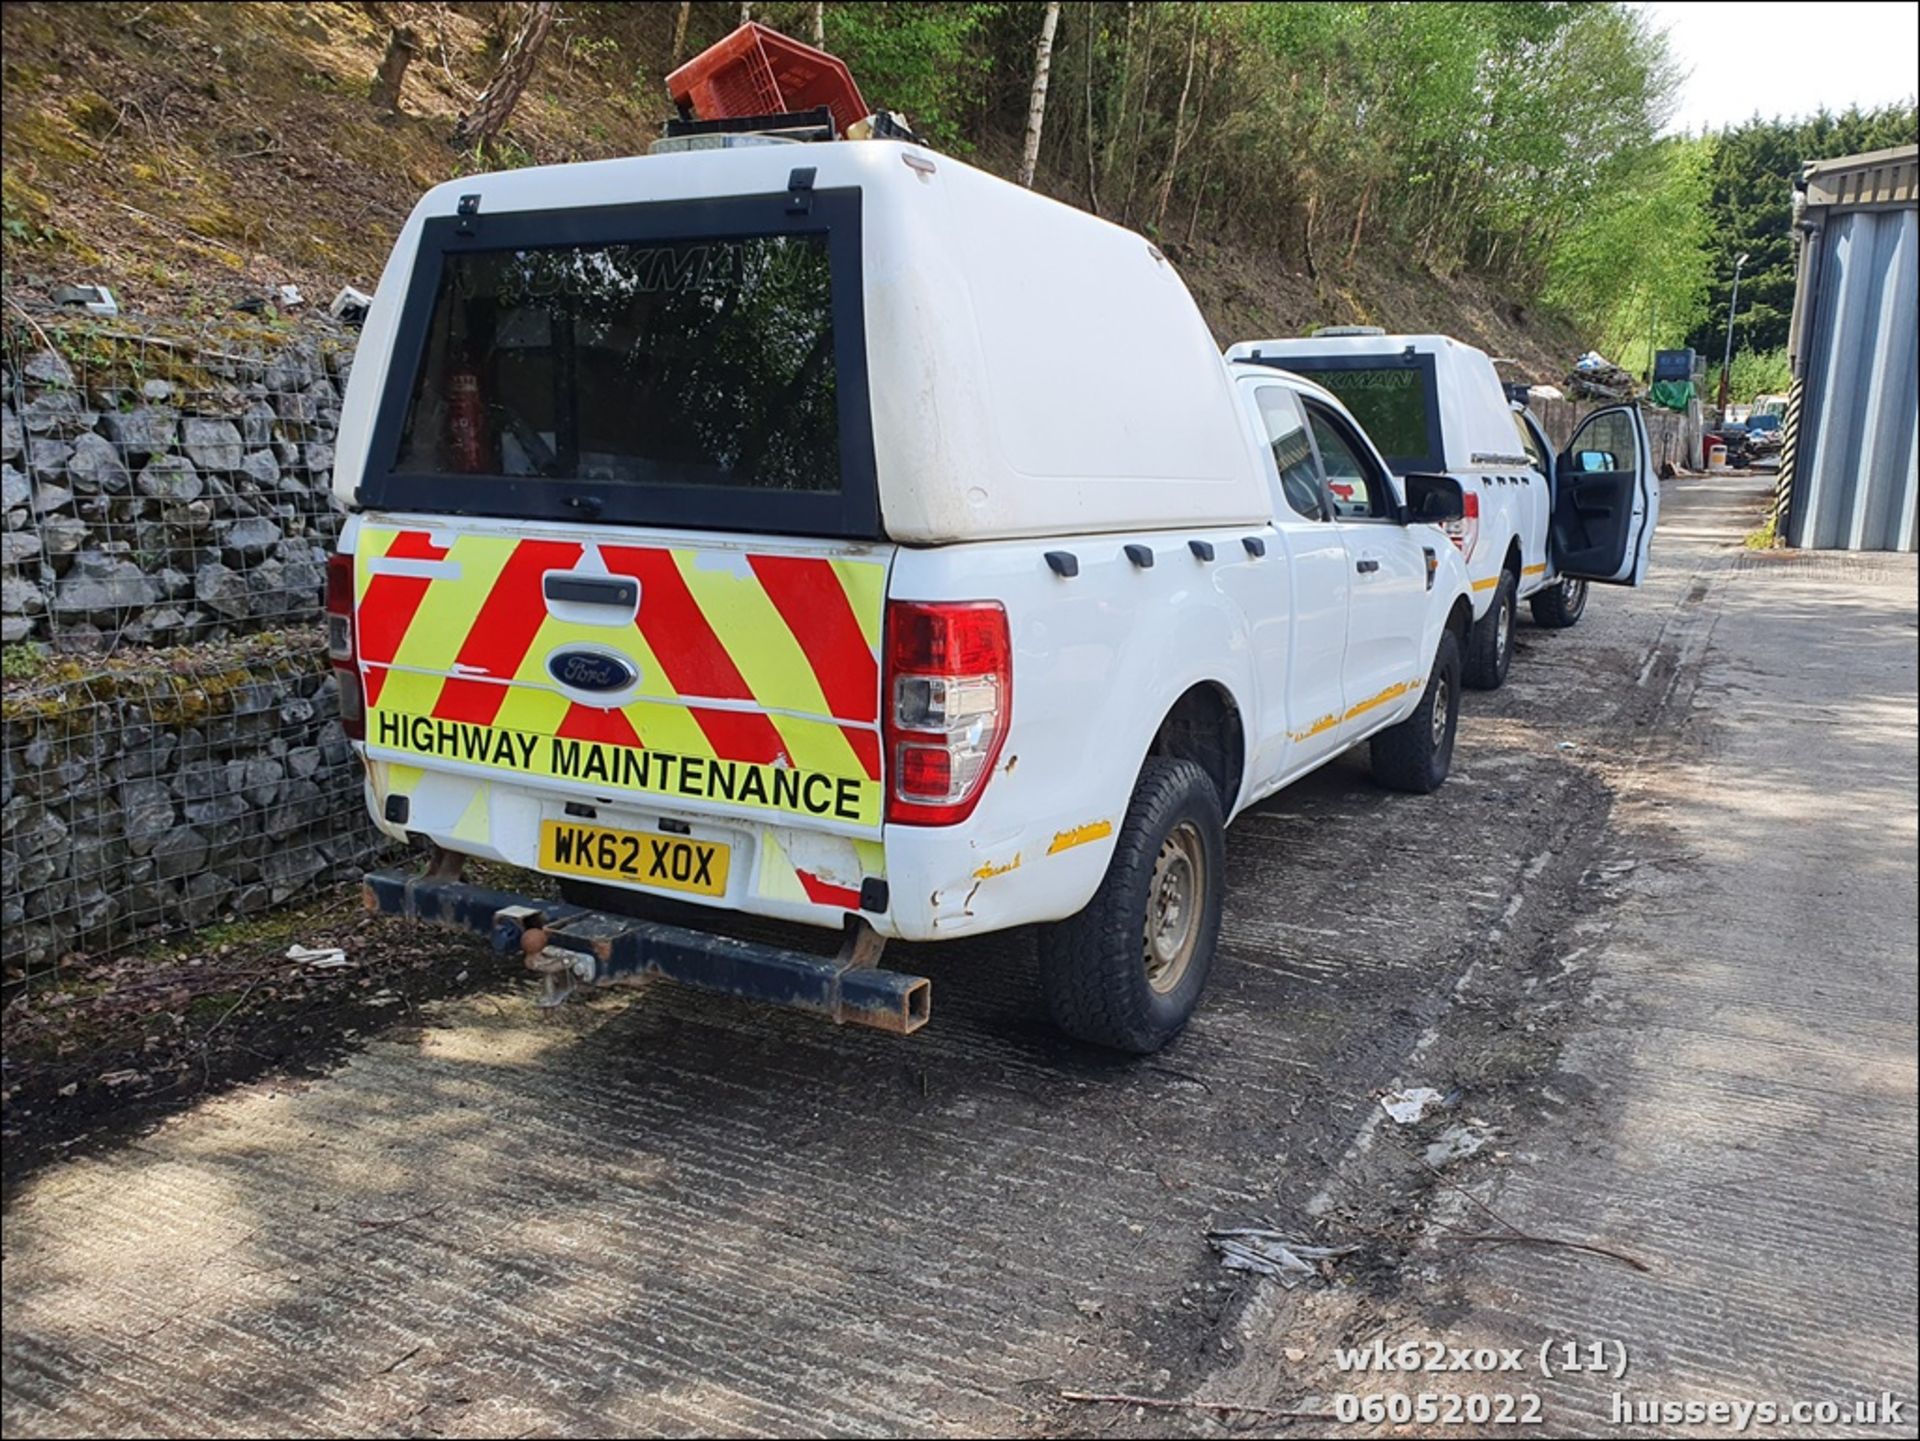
xmin=1688 ymin=104 xmax=1916 ymax=359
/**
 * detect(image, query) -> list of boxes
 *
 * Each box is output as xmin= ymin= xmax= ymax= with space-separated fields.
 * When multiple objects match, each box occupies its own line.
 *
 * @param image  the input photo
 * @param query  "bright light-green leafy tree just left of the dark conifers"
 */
xmin=1544 ymin=140 xmax=1711 ymax=372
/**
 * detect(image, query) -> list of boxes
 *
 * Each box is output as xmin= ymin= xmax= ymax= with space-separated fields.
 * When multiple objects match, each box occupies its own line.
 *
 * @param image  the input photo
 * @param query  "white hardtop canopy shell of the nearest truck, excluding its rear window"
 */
xmin=334 ymin=140 xmax=1271 ymax=543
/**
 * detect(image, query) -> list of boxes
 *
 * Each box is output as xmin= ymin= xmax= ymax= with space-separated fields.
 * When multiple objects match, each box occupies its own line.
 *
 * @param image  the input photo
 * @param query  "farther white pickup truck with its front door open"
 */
xmin=1227 ymin=326 xmax=1661 ymax=691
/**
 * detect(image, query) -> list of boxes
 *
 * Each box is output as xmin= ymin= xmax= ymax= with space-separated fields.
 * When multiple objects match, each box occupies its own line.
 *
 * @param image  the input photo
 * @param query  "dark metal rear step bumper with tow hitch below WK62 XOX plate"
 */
xmin=363 ymin=871 xmax=933 ymax=1036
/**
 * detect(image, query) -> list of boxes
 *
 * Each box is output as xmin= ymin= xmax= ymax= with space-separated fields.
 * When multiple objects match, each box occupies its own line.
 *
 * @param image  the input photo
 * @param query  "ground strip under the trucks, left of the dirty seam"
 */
xmin=4 ymin=482 xmax=1912 ymax=1435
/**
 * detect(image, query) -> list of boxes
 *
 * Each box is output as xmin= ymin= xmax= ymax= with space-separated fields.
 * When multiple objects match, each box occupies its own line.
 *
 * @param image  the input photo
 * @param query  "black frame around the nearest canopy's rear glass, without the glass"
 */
xmin=353 ymin=186 xmax=885 ymax=541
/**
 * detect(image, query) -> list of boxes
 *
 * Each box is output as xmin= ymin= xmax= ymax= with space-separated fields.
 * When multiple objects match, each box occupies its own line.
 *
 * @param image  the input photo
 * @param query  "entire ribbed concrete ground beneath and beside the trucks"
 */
xmin=0 ymin=480 xmax=1916 ymax=1435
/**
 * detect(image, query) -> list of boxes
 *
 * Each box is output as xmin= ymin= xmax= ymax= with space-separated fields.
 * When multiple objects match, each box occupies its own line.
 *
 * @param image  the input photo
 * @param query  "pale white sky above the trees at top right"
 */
xmin=1642 ymin=0 xmax=1920 ymax=134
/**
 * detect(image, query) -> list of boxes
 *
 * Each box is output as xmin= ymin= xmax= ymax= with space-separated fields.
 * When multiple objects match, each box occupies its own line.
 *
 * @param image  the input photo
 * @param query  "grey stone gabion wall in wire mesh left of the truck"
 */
xmin=0 ymin=307 xmax=382 ymax=979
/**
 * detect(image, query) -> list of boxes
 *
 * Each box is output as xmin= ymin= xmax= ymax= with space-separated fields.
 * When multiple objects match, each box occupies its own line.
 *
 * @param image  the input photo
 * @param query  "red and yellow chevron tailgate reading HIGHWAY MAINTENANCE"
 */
xmin=355 ymin=514 xmax=891 ymax=863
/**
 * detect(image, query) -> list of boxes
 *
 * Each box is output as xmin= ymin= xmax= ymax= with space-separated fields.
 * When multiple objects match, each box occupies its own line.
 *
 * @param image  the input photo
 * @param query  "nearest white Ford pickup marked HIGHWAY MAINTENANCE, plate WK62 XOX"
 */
xmin=328 ymin=138 xmax=1471 ymax=1051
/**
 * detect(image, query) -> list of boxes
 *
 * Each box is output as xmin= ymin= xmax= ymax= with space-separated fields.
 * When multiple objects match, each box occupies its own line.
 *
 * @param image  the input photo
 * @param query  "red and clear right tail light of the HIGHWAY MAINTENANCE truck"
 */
xmin=883 ymin=601 xmax=1014 ymax=825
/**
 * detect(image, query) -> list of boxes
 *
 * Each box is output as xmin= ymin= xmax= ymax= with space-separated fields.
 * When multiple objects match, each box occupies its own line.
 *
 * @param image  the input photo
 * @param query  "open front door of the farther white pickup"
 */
xmin=1551 ymin=405 xmax=1661 ymax=585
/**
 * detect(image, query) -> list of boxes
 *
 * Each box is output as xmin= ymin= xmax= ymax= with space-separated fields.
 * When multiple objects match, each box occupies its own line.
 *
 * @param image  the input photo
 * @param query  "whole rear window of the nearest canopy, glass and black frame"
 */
xmin=361 ymin=190 xmax=879 ymax=537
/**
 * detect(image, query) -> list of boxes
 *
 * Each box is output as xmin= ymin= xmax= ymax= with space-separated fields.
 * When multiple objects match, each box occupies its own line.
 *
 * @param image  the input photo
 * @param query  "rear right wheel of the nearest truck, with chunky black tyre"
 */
xmin=1041 ymin=756 xmax=1225 ymax=1055
